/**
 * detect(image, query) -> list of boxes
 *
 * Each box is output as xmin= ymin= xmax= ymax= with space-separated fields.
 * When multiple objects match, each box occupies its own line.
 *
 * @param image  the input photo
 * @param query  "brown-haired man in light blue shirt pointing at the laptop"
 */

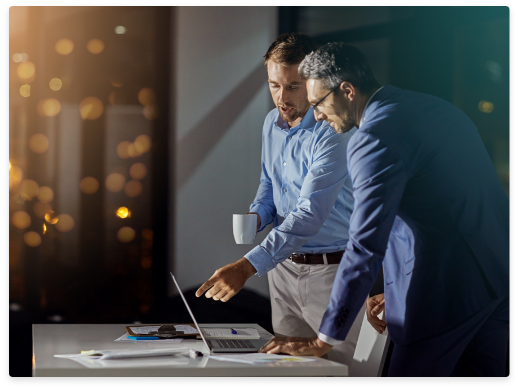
xmin=197 ymin=34 xmax=364 ymax=364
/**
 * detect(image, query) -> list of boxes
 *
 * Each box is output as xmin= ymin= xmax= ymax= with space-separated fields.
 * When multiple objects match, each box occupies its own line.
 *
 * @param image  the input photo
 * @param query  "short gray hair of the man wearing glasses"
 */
xmin=299 ymin=42 xmax=380 ymax=94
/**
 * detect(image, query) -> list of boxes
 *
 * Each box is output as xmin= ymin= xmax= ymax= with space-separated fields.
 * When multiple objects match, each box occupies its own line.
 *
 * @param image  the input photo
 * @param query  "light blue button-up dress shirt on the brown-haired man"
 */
xmin=245 ymin=108 xmax=355 ymax=276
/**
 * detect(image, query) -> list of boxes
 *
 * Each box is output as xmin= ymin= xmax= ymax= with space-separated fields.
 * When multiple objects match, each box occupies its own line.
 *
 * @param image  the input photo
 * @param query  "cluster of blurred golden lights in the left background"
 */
xmin=9 ymin=26 xmax=157 ymax=247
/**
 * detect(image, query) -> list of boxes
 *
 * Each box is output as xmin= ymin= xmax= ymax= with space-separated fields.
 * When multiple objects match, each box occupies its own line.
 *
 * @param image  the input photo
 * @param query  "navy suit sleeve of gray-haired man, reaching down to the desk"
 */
xmin=320 ymin=131 xmax=407 ymax=340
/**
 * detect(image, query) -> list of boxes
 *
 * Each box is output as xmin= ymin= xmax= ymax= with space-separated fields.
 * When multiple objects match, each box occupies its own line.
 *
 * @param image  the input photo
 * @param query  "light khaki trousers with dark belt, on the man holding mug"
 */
xmin=268 ymin=260 xmax=366 ymax=366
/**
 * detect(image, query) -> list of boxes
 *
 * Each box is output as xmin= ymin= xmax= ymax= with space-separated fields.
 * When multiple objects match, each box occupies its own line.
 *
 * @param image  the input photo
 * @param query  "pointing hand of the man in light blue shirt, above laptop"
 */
xmin=196 ymin=258 xmax=258 ymax=303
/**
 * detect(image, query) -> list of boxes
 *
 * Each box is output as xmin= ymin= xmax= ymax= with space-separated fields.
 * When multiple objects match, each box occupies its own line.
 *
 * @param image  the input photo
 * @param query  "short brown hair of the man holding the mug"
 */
xmin=264 ymin=33 xmax=319 ymax=67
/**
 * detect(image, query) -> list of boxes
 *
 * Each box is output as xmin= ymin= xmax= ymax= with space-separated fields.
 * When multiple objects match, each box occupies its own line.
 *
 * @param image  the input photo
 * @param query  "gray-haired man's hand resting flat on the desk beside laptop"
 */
xmin=259 ymin=337 xmax=333 ymax=358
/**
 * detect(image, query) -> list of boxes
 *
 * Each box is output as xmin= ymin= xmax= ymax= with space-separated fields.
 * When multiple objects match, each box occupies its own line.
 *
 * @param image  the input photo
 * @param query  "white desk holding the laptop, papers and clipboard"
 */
xmin=33 ymin=324 xmax=349 ymax=377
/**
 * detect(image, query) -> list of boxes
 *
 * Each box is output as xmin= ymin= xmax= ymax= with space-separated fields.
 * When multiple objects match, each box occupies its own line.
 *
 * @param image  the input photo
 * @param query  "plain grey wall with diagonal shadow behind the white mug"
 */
xmin=170 ymin=6 xmax=278 ymax=295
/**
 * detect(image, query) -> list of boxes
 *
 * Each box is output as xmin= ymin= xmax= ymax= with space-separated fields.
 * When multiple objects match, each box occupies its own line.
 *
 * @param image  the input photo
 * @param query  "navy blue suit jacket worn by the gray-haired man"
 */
xmin=321 ymin=86 xmax=510 ymax=345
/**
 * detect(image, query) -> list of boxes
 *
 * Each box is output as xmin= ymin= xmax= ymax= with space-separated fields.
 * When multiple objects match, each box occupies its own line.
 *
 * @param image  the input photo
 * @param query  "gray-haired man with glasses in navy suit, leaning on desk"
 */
xmin=263 ymin=43 xmax=510 ymax=376
